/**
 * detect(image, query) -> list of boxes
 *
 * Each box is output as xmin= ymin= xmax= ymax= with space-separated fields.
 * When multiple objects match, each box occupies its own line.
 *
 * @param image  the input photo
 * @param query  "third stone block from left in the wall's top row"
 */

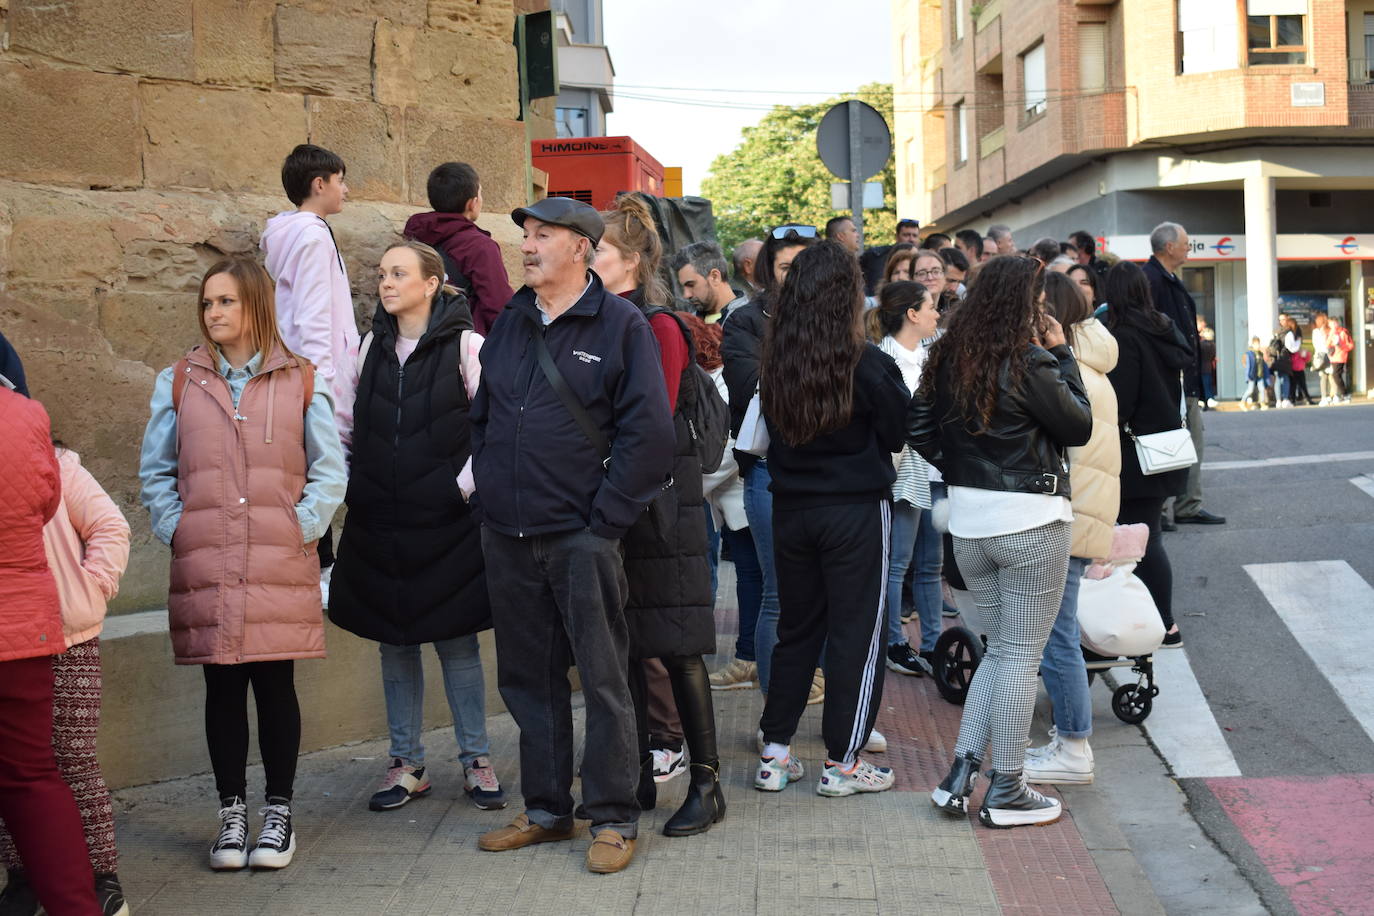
xmin=276 ymin=7 xmax=374 ymax=98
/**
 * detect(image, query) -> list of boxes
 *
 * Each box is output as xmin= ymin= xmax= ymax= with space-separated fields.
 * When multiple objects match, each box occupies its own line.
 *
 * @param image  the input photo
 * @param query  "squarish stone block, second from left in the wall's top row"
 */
xmin=195 ymin=0 xmax=276 ymax=87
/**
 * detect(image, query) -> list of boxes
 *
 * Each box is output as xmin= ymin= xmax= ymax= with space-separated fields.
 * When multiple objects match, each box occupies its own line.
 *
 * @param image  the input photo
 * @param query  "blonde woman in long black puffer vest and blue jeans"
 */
xmin=330 ymin=240 xmax=506 ymax=810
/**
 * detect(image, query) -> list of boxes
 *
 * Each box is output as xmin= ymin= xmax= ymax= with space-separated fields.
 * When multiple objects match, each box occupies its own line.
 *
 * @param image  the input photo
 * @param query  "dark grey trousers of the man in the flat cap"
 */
xmin=482 ymin=527 xmax=639 ymax=839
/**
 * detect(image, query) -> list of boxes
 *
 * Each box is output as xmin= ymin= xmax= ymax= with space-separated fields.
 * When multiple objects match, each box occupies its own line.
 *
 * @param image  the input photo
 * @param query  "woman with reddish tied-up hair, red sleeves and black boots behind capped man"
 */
xmin=594 ymin=194 xmax=725 ymax=836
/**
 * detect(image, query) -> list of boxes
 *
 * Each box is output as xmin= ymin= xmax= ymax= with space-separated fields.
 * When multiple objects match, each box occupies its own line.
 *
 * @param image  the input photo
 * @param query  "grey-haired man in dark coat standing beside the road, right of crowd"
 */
xmin=1142 ymin=222 xmax=1226 ymax=525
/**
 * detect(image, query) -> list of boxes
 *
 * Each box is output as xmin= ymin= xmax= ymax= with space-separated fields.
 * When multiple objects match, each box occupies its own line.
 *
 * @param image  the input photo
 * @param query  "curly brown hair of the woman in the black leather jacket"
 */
xmin=919 ymin=254 xmax=1044 ymax=428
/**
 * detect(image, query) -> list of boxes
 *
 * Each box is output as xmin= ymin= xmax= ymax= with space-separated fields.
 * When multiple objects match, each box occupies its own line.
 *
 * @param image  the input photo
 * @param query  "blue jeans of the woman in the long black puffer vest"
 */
xmin=379 ymin=633 xmax=491 ymax=766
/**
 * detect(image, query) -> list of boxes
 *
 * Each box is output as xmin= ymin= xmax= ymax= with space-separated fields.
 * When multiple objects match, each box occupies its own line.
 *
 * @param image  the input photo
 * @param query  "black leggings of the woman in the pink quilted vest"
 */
xmin=202 ymin=659 xmax=301 ymax=801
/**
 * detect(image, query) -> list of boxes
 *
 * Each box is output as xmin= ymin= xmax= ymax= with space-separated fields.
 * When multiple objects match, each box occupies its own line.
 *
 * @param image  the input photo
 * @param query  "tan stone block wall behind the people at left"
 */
xmin=0 ymin=0 xmax=551 ymax=611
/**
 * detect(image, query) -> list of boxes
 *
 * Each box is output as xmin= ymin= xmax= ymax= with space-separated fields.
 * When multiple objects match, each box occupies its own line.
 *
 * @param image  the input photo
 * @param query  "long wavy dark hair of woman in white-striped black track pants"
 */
xmin=758 ymin=242 xmax=867 ymax=446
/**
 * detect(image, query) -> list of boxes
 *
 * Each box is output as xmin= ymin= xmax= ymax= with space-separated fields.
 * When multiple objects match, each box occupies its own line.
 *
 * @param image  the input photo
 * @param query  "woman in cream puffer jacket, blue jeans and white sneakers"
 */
xmin=1022 ymin=273 xmax=1121 ymax=784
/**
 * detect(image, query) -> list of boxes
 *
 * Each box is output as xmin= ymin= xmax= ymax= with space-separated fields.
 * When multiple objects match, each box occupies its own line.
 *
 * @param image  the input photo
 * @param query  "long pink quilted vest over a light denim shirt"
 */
xmin=168 ymin=346 xmax=324 ymax=665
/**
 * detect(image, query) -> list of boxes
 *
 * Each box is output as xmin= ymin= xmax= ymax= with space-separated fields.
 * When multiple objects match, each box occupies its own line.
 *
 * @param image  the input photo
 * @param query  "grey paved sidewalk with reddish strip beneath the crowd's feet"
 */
xmin=107 ymin=564 xmax=1162 ymax=916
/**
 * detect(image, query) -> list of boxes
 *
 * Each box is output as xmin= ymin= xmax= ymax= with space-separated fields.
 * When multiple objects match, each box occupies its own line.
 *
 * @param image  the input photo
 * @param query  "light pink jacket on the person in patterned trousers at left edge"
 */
xmin=43 ymin=449 xmax=129 ymax=648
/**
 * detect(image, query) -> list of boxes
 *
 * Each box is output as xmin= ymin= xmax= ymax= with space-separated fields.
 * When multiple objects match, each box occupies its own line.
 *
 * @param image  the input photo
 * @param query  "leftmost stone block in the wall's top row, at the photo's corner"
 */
xmin=10 ymin=0 xmax=195 ymax=80
